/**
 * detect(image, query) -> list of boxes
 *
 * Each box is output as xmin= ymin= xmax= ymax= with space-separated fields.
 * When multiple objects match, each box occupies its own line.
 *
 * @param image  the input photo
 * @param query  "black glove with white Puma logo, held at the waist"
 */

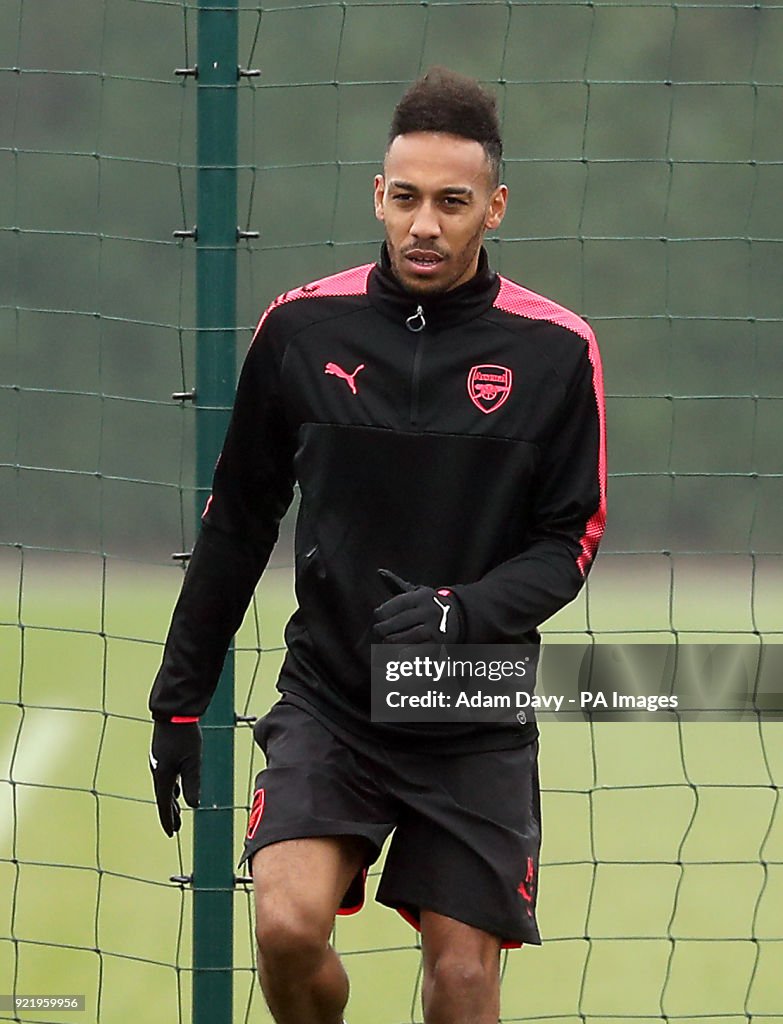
xmin=375 ymin=569 xmax=464 ymax=643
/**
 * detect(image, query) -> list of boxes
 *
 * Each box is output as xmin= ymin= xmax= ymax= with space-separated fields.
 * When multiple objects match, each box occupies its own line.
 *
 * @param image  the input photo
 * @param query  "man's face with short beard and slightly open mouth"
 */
xmin=375 ymin=132 xmax=508 ymax=295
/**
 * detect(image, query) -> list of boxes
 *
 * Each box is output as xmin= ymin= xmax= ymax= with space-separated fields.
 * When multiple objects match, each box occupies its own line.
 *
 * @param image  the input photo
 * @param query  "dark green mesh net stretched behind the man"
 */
xmin=0 ymin=0 xmax=783 ymax=1024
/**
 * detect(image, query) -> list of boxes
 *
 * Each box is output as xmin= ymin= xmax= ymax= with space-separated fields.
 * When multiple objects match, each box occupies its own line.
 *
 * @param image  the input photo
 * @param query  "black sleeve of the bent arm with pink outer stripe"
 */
xmin=452 ymin=333 xmax=606 ymax=643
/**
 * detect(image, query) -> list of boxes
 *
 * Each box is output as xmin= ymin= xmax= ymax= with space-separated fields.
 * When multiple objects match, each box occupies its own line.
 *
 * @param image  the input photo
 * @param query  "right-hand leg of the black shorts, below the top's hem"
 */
xmin=378 ymin=743 xmax=540 ymax=947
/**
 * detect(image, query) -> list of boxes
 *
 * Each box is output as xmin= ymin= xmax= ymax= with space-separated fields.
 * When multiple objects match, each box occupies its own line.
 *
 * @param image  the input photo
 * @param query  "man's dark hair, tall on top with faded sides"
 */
xmin=387 ymin=68 xmax=503 ymax=185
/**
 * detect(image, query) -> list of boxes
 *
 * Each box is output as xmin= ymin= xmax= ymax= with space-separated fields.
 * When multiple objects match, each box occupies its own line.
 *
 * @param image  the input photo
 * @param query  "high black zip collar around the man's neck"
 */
xmin=367 ymin=243 xmax=501 ymax=331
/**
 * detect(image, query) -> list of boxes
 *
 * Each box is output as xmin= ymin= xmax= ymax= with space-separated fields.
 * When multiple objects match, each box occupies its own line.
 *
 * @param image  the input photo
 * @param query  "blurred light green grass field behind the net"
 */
xmin=0 ymin=549 xmax=783 ymax=1024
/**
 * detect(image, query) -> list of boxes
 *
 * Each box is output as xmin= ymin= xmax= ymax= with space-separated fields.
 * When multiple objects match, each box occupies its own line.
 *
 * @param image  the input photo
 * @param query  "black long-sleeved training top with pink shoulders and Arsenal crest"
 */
xmin=149 ymin=250 xmax=606 ymax=750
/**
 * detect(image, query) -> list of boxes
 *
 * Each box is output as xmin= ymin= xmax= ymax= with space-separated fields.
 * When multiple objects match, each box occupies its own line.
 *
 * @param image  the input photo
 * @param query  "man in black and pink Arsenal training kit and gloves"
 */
xmin=150 ymin=70 xmax=605 ymax=1024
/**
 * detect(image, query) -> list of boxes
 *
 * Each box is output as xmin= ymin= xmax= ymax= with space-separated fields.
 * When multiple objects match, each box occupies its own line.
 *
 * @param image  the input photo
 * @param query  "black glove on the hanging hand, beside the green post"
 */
xmin=149 ymin=721 xmax=202 ymax=836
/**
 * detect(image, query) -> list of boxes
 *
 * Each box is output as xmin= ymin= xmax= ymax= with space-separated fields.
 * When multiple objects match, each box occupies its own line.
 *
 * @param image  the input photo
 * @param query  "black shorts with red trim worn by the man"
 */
xmin=242 ymin=698 xmax=540 ymax=947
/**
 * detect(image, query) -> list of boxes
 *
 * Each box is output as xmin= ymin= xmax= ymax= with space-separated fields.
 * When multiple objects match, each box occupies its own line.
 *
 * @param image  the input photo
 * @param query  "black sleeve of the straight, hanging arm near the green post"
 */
xmin=149 ymin=317 xmax=295 ymax=721
